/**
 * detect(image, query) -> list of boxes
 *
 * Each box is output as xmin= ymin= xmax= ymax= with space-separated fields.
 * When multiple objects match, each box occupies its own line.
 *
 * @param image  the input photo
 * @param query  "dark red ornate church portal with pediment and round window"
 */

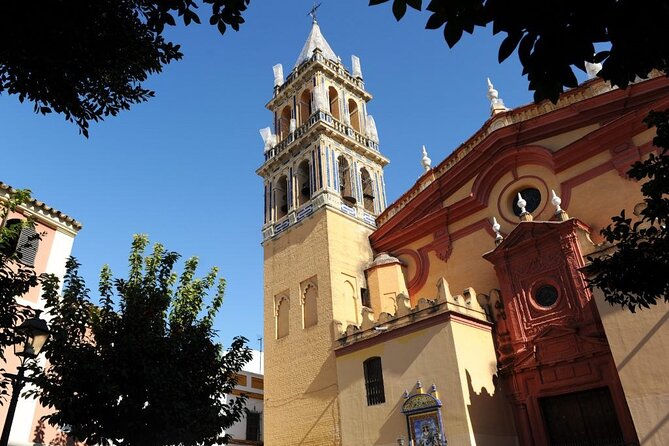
xmin=485 ymin=219 xmax=638 ymax=446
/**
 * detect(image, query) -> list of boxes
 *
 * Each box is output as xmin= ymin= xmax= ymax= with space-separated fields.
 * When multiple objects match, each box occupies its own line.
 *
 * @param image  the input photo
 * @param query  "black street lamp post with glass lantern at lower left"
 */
xmin=0 ymin=311 xmax=51 ymax=446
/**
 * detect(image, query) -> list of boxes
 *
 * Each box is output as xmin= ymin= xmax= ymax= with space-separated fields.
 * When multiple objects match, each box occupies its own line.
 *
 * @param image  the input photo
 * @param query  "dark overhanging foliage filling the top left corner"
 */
xmin=0 ymin=0 xmax=250 ymax=136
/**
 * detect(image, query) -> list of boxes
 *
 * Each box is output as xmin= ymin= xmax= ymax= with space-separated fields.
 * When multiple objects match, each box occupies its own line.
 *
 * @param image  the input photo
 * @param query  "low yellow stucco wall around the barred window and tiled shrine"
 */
xmin=337 ymin=322 xmax=516 ymax=446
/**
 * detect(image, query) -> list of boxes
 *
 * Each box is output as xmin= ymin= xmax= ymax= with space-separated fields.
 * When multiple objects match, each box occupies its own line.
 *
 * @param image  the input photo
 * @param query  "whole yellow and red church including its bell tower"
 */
xmin=257 ymin=20 xmax=669 ymax=446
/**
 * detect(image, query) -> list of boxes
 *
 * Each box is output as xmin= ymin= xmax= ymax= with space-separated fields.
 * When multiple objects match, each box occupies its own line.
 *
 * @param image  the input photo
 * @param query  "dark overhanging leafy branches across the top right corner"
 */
xmin=369 ymin=0 xmax=669 ymax=102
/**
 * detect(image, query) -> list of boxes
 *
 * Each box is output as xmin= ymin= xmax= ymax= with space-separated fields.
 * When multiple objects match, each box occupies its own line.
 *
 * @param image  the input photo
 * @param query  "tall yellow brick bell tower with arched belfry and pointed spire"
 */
xmin=257 ymin=16 xmax=388 ymax=446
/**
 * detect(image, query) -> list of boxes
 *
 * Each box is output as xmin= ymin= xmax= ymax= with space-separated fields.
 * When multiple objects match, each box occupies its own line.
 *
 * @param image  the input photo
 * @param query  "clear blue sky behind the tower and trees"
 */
xmin=0 ymin=0 xmax=584 ymax=348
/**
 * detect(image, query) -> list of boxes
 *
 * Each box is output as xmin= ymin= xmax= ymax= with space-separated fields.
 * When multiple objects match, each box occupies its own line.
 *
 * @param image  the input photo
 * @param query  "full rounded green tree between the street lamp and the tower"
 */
xmin=33 ymin=236 xmax=251 ymax=446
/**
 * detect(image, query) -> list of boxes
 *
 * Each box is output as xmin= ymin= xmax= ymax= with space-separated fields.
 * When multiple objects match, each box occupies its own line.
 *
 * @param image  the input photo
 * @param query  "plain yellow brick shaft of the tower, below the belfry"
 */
xmin=264 ymin=209 xmax=372 ymax=446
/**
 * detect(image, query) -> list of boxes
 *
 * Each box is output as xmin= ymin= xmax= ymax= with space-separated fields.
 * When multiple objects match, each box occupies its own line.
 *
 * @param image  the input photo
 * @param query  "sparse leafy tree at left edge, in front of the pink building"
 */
xmin=0 ymin=190 xmax=38 ymax=404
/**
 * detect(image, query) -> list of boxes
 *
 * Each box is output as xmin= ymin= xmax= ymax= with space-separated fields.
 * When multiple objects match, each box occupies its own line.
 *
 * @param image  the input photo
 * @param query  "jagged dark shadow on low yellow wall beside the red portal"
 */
xmin=465 ymin=370 xmax=517 ymax=446
